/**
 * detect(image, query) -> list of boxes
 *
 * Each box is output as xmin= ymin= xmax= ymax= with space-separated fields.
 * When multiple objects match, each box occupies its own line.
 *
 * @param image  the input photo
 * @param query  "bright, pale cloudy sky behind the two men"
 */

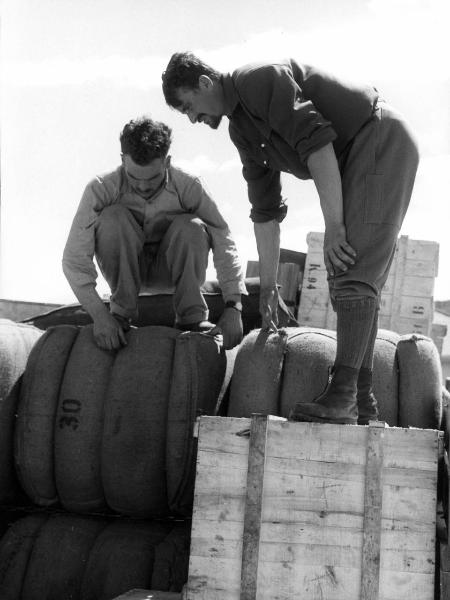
xmin=0 ymin=0 xmax=450 ymax=302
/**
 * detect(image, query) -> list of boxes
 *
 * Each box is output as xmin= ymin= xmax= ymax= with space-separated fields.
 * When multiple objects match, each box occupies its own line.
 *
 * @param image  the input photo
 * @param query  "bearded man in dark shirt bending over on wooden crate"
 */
xmin=162 ymin=52 xmax=418 ymax=423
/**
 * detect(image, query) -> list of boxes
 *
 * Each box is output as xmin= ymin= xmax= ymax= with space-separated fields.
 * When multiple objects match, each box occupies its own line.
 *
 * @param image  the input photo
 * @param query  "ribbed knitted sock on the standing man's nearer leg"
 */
xmin=335 ymin=296 xmax=377 ymax=369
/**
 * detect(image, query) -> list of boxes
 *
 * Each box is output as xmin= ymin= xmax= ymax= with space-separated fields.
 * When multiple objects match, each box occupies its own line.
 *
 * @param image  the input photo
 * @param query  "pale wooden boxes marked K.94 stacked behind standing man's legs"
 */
xmin=297 ymin=232 xmax=439 ymax=336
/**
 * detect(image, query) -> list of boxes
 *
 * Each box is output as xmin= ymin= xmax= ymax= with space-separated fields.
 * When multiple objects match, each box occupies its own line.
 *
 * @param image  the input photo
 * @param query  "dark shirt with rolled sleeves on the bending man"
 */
xmin=222 ymin=59 xmax=378 ymax=222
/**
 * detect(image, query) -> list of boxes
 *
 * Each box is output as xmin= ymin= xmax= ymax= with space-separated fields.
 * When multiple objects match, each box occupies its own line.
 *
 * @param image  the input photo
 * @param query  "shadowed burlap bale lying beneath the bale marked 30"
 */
xmin=0 ymin=511 xmax=190 ymax=600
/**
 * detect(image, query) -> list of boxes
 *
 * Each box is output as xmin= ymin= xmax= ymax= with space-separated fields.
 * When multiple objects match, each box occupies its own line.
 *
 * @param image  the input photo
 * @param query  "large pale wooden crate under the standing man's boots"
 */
xmin=185 ymin=416 xmax=440 ymax=600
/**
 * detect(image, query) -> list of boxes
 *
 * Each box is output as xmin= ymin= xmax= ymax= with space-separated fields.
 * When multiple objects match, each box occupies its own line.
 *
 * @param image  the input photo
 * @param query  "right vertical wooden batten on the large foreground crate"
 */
xmin=361 ymin=422 xmax=385 ymax=600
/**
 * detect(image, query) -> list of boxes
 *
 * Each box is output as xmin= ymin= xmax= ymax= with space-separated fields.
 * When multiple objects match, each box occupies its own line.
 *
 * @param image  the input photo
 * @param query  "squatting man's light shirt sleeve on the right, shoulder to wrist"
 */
xmin=180 ymin=178 xmax=247 ymax=300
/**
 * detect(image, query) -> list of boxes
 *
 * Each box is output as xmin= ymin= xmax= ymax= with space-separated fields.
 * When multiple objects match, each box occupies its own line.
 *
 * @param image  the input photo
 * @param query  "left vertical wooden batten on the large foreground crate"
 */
xmin=240 ymin=415 xmax=268 ymax=600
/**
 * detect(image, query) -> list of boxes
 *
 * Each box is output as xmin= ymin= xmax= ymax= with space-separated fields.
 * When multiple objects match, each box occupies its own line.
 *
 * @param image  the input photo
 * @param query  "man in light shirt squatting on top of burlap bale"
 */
xmin=63 ymin=117 xmax=246 ymax=350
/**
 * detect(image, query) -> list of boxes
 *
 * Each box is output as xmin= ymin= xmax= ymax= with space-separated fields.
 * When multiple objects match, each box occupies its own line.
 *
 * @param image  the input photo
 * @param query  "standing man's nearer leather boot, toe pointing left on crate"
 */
xmin=289 ymin=365 xmax=358 ymax=425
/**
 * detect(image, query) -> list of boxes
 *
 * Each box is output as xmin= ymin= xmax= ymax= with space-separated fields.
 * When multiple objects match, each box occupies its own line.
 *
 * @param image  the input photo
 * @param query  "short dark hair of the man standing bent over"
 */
xmin=162 ymin=52 xmax=221 ymax=108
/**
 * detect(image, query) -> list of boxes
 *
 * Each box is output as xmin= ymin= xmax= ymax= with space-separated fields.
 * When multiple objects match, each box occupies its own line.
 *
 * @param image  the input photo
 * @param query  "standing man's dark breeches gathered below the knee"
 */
xmin=329 ymin=102 xmax=419 ymax=301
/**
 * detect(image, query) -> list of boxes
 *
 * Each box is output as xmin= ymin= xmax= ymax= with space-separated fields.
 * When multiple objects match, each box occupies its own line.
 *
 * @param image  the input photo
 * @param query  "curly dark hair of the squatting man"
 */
xmin=120 ymin=117 xmax=172 ymax=166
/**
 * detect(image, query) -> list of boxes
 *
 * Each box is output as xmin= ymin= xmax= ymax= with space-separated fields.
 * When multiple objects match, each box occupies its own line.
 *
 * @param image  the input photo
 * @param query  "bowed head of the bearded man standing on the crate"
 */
xmin=162 ymin=52 xmax=225 ymax=129
